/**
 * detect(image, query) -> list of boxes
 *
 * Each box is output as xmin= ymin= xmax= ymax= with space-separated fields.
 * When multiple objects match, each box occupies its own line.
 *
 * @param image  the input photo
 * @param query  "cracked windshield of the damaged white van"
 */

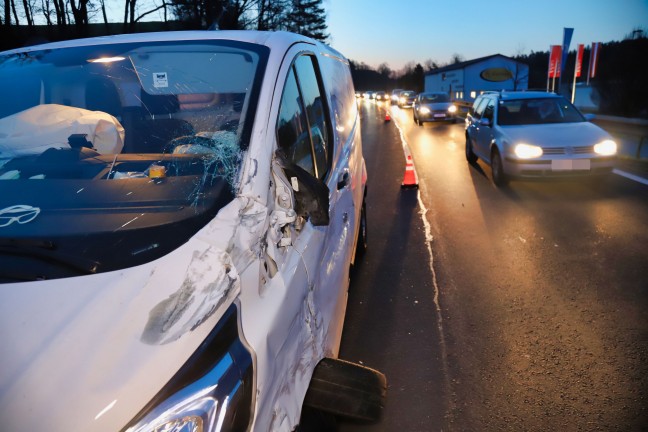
xmin=0 ymin=41 xmax=268 ymax=282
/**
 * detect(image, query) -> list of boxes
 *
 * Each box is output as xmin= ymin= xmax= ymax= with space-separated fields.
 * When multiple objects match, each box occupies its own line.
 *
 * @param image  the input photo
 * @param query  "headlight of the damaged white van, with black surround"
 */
xmin=125 ymin=305 xmax=254 ymax=432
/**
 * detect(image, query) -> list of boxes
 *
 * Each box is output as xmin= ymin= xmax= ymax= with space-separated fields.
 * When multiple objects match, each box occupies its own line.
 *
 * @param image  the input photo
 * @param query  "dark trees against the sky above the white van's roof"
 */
xmin=0 ymin=0 xmax=329 ymax=50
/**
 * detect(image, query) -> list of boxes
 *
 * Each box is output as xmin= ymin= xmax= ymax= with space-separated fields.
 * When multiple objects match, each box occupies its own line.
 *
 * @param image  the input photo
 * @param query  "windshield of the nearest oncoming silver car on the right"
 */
xmin=497 ymin=97 xmax=586 ymax=126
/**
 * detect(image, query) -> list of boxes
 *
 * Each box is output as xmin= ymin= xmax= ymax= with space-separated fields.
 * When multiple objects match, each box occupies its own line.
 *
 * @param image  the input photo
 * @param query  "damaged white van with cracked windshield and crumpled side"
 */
xmin=0 ymin=31 xmax=385 ymax=432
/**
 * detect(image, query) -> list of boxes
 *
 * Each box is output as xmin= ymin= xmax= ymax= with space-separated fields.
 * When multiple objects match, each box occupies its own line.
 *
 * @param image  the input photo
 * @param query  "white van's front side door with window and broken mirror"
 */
xmin=277 ymin=53 xmax=355 ymax=356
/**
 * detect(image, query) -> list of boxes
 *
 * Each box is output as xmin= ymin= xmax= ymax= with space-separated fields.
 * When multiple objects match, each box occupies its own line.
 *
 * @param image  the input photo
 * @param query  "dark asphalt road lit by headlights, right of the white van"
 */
xmin=340 ymin=101 xmax=648 ymax=432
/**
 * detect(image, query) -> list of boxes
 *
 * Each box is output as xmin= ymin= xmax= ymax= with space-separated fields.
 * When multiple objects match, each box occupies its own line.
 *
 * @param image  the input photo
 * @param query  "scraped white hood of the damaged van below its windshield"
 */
xmin=0 ymin=200 xmax=263 ymax=432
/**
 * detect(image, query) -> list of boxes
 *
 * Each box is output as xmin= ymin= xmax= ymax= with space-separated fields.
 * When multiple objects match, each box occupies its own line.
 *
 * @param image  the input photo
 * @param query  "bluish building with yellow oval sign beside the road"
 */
xmin=424 ymin=54 xmax=529 ymax=102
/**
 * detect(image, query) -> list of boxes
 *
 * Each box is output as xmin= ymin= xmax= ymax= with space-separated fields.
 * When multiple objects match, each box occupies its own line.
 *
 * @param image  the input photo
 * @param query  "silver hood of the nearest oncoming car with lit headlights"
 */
xmin=500 ymin=122 xmax=610 ymax=147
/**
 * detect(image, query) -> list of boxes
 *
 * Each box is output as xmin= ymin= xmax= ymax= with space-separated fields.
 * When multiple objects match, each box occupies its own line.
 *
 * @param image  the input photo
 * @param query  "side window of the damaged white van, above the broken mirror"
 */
xmin=277 ymin=55 xmax=330 ymax=179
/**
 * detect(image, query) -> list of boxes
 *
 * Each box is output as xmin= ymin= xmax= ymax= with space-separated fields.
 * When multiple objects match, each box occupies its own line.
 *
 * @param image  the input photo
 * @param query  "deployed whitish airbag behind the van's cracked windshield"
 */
xmin=0 ymin=104 xmax=124 ymax=158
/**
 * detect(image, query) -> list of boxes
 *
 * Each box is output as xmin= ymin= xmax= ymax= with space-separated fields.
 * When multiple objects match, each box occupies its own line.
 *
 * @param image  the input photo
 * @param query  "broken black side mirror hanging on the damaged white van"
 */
xmin=275 ymin=149 xmax=329 ymax=226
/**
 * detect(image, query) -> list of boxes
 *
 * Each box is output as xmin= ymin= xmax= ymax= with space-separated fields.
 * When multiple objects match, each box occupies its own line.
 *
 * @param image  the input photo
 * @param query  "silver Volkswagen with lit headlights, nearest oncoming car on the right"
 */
xmin=465 ymin=91 xmax=617 ymax=186
